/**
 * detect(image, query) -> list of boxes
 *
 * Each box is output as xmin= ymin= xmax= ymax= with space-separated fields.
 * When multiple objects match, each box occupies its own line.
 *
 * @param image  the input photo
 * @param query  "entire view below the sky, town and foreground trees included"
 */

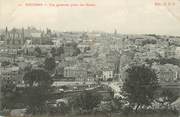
xmin=0 ymin=26 xmax=180 ymax=117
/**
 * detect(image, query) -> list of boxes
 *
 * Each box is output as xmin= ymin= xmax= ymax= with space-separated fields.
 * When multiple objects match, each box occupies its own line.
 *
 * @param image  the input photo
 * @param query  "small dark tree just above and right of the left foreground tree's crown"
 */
xmin=44 ymin=57 xmax=56 ymax=71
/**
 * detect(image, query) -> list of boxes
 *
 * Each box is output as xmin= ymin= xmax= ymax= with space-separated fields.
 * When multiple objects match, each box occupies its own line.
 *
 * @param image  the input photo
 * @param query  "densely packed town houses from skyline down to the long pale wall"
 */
xmin=0 ymin=27 xmax=180 ymax=86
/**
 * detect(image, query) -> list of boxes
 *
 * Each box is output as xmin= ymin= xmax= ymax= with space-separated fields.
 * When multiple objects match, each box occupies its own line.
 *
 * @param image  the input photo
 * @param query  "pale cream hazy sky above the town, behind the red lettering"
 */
xmin=0 ymin=0 xmax=180 ymax=35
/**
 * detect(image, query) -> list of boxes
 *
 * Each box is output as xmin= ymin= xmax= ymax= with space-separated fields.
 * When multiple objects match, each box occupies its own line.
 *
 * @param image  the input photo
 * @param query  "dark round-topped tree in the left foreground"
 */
xmin=23 ymin=69 xmax=52 ymax=114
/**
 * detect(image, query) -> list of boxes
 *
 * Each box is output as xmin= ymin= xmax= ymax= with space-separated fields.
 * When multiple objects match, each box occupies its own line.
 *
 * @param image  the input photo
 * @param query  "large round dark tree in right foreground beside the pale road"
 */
xmin=123 ymin=65 xmax=158 ymax=111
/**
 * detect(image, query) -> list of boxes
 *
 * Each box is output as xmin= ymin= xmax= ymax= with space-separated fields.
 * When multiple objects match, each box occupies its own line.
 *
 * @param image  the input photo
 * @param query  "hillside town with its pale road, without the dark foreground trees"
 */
xmin=0 ymin=27 xmax=180 ymax=116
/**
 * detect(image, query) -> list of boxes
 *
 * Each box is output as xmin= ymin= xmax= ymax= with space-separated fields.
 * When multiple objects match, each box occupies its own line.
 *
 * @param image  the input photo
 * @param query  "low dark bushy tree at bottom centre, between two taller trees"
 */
xmin=74 ymin=90 xmax=102 ymax=112
